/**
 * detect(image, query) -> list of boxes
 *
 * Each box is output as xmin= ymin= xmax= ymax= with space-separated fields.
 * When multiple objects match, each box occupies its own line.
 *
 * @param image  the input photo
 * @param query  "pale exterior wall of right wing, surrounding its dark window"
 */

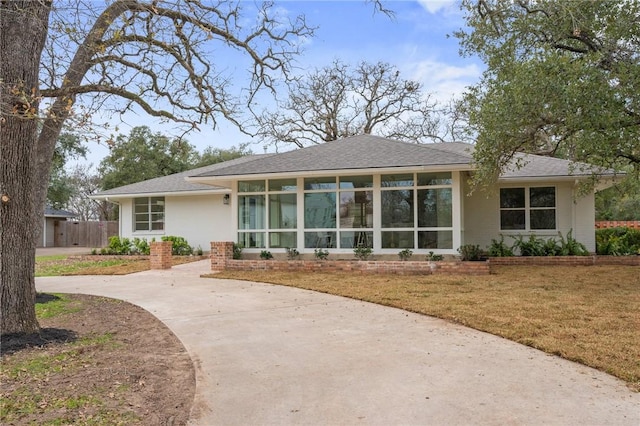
xmin=463 ymin=181 xmax=596 ymax=252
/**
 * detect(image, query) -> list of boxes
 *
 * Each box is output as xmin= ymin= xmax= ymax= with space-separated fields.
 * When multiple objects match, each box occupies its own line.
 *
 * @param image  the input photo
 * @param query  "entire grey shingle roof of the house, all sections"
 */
xmin=94 ymin=135 xmax=613 ymax=198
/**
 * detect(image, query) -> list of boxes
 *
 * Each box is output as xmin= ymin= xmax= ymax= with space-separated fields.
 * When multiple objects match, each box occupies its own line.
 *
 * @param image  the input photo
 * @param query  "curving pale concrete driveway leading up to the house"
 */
xmin=36 ymin=261 xmax=640 ymax=426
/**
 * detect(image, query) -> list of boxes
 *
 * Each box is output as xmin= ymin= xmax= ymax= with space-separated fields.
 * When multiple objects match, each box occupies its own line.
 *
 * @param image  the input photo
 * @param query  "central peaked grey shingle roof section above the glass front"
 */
xmin=189 ymin=135 xmax=471 ymax=177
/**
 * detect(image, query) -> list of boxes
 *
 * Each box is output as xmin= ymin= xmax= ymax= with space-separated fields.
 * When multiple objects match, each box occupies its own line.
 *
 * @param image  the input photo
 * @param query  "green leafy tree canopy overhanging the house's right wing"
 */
xmin=456 ymin=0 xmax=640 ymax=189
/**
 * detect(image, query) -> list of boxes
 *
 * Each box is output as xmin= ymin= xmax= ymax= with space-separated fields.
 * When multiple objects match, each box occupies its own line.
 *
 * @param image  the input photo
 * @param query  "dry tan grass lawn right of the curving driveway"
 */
xmin=210 ymin=266 xmax=640 ymax=391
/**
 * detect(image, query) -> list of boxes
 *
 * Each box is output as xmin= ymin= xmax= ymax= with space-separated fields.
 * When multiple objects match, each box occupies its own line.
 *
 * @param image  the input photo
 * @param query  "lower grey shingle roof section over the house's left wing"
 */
xmin=94 ymin=154 xmax=273 ymax=197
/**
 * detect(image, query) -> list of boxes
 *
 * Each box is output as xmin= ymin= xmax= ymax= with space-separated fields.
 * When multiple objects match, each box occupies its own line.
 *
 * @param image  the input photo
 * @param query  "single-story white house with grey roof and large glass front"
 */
xmin=92 ymin=135 xmax=616 ymax=255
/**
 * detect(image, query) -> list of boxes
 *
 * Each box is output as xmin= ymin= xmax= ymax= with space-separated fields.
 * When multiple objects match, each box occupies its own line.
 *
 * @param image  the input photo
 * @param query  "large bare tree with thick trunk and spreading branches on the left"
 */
xmin=0 ymin=0 xmax=313 ymax=334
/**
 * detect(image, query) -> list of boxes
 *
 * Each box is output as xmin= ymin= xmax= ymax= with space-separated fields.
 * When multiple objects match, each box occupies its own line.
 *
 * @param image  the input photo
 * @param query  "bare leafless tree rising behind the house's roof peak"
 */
xmin=252 ymin=61 xmax=442 ymax=147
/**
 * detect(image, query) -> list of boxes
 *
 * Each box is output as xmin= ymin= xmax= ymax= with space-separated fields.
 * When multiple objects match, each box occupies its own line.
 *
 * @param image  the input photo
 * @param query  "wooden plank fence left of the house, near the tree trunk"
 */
xmin=54 ymin=220 xmax=118 ymax=248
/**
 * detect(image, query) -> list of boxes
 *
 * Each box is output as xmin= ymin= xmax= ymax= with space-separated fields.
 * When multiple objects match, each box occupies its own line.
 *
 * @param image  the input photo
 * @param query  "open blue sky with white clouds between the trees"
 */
xmin=83 ymin=0 xmax=484 ymax=166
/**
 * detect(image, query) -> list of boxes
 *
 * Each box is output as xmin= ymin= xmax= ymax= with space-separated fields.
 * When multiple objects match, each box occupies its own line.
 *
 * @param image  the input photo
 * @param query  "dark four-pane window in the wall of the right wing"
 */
xmin=500 ymin=186 xmax=556 ymax=231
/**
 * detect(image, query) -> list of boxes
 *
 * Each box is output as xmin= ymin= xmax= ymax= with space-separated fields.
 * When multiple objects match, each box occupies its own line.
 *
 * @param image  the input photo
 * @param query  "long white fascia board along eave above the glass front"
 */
xmin=185 ymin=164 xmax=474 ymax=185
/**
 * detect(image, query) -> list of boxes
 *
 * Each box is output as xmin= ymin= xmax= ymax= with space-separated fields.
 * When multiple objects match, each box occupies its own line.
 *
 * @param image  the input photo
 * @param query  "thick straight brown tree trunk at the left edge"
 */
xmin=0 ymin=0 xmax=51 ymax=334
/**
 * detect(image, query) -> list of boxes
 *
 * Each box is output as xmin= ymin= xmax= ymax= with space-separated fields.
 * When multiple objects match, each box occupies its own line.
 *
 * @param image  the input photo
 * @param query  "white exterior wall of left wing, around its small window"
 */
xmin=120 ymin=194 xmax=235 ymax=251
